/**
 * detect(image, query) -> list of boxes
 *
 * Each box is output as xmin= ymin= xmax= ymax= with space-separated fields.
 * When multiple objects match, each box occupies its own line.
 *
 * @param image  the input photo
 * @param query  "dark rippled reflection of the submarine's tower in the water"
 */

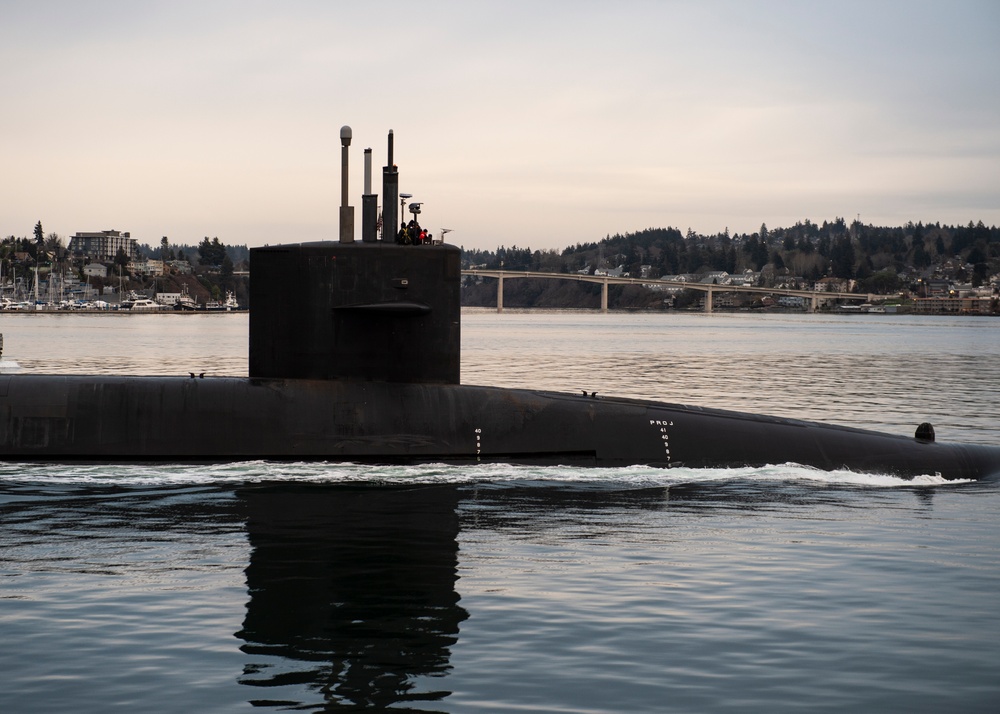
xmin=236 ymin=484 xmax=468 ymax=711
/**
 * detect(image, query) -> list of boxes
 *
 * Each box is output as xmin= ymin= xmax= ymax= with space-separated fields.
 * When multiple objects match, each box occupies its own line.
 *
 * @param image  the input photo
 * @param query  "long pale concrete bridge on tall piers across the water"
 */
xmin=462 ymin=268 xmax=885 ymax=312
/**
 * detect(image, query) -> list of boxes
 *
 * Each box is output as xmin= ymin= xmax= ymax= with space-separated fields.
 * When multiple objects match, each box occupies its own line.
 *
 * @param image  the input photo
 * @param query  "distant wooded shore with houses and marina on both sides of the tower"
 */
xmin=0 ymin=218 xmax=1000 ymax=315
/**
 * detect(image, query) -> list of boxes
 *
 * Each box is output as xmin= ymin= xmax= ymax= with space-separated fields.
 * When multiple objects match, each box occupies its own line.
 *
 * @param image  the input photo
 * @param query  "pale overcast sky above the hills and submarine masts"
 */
xmin=0 ymin=0 xmax=1000 ymax=249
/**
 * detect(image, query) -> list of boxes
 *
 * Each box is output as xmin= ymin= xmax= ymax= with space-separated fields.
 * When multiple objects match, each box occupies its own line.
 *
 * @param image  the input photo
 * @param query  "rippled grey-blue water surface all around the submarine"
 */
xmin=0 ymin=311 xmax=1000 ymax=712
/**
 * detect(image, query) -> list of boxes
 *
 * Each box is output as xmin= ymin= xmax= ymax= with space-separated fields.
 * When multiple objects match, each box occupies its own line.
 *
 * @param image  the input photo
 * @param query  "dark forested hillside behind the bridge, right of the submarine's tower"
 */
xmin=462 ymin=218 xmax=1000 ymax=307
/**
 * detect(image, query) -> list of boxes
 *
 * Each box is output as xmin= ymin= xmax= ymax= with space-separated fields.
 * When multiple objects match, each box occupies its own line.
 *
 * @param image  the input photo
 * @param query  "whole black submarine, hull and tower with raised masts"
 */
xmin=0 ymin=127 xmax=1000 ymax=479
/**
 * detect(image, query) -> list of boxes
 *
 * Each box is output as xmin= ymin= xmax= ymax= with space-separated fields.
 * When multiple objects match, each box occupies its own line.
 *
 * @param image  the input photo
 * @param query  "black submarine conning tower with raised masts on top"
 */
xmin=249 ymin=127 xmax=461 ymax=384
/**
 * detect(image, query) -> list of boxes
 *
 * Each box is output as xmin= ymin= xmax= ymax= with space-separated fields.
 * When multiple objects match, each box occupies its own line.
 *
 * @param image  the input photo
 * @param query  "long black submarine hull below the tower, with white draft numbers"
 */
xmin=7 ymin=375 xmax=1000 ymax=479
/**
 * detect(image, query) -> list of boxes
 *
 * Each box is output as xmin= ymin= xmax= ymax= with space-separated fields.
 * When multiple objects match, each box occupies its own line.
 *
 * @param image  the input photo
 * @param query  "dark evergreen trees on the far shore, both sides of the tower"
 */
xmin=0 ymin=218 xmax=1000 ymax=307
